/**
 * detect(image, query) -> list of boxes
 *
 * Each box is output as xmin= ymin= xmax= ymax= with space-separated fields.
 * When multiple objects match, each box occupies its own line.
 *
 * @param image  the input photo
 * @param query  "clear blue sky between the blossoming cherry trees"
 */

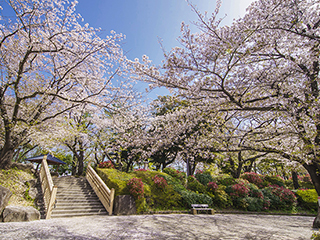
xmin=77 ymin=0 xmax=254 ymax=99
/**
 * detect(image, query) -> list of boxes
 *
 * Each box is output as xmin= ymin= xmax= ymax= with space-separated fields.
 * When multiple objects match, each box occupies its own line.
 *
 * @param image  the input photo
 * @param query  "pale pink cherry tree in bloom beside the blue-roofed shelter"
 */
xmin=0 ymin=0 xmax=130 ymax=168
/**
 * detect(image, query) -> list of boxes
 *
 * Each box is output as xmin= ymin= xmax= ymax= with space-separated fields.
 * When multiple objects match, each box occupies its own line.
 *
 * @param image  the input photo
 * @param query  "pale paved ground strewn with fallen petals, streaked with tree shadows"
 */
xmin=0 ymin=214 xmax=314 ymax=240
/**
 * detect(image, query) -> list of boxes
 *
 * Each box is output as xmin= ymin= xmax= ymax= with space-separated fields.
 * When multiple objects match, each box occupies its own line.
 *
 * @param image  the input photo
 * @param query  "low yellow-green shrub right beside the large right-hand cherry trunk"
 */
xmin=296 ymin=189 xmax=318 ymax=211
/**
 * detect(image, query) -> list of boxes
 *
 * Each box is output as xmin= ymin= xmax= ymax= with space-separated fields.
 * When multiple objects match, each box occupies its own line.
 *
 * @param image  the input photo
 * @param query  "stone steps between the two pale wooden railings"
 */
xmin=51 ymin=176 xmax=108 ymax=218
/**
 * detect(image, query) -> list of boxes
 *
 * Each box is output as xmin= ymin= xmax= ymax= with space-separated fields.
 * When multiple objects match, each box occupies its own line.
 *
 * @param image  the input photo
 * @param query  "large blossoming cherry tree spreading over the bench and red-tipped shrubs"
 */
xmin=132 ymin=0 xmax=320 ymax=227
